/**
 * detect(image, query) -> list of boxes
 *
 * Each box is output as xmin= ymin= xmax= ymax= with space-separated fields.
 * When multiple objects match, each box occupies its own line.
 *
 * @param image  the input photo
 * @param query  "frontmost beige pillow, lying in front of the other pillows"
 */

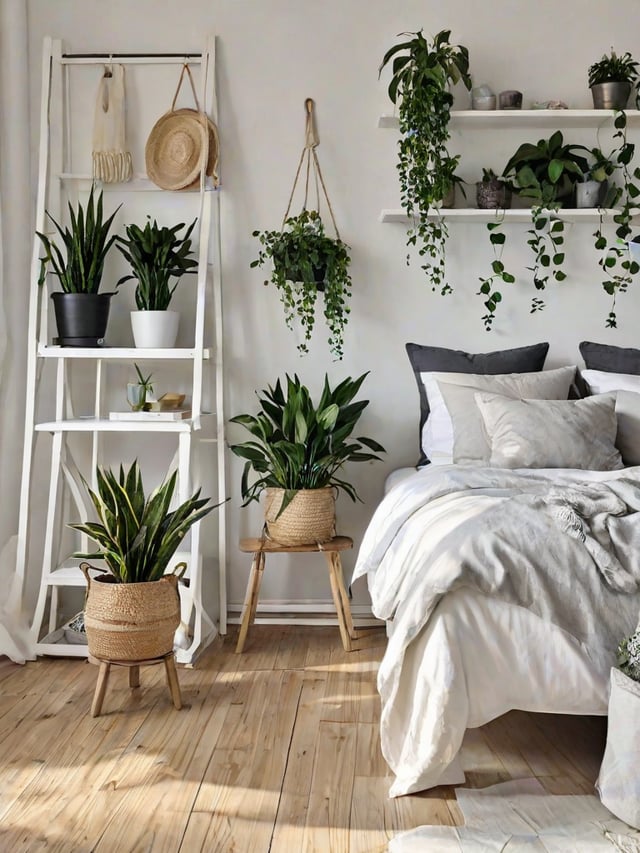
xmin=476 ymin=392 xmax=624 ymax=471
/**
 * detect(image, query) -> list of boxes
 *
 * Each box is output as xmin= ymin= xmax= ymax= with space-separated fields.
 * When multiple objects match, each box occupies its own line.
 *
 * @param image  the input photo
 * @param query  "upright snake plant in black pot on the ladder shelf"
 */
xmin=36 ymin=185 xmax=119 ymax=347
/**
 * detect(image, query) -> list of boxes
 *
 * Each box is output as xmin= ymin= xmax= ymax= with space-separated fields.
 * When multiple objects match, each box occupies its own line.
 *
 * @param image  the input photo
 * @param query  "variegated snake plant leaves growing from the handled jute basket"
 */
xmin=69 ymin=462 xmax=215 ymax=583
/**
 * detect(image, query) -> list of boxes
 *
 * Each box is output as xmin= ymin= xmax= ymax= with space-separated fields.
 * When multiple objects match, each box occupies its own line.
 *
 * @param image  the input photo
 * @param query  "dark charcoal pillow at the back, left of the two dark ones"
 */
xmin=405 ymin=342 xmax=549 ymax=466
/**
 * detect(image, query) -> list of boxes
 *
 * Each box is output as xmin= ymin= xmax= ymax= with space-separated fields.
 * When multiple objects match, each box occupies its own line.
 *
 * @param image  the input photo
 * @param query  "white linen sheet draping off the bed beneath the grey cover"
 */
xmin=352 ymin=466 xmax=640 ymax=796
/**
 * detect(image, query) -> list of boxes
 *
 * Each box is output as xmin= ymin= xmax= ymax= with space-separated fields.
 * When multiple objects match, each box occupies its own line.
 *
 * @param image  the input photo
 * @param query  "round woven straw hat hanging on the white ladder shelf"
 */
xmin=145 ymin=109 xmax=218 ymax=190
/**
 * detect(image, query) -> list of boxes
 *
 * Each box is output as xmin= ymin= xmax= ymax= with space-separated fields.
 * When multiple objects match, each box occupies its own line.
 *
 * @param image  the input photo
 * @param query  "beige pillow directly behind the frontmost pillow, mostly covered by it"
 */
xmin=432 ymin=365 xmax=576 ymax=465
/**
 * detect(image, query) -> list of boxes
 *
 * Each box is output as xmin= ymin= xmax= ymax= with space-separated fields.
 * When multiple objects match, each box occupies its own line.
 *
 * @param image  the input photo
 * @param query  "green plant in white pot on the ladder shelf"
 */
xmin=116 ymin=217 xmax=198 ymax=348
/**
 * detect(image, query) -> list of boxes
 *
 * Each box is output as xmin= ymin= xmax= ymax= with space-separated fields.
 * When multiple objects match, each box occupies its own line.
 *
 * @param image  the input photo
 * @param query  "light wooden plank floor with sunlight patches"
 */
xmin=0 ymin=625 xmax=606 ymax=853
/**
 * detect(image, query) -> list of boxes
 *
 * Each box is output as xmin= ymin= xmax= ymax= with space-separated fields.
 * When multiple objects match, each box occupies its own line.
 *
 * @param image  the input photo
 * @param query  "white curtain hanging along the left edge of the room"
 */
xmin=0 ymin=0 xmax=33 ymax=663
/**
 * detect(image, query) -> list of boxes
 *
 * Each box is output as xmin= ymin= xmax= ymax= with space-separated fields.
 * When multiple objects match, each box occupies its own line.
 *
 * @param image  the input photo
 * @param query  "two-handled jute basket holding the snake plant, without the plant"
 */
xmin=83 ymin=568 xmax=180 ymax=661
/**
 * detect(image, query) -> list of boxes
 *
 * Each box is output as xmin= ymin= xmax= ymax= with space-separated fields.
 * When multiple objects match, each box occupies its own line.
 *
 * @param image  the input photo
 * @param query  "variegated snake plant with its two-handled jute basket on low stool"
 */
xmin=69 ymin=462 xmax=214 ymax=660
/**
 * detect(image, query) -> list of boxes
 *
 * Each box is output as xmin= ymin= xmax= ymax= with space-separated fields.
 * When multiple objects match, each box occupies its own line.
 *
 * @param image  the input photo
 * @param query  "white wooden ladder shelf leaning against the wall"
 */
xmin=15 ymin=36 xmax=227 ymax=664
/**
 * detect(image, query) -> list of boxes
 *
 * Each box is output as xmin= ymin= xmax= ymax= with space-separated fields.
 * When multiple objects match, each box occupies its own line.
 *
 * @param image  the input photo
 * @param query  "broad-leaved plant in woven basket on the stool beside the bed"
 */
xmin=230 ymin=373 xmax=384 ymax=545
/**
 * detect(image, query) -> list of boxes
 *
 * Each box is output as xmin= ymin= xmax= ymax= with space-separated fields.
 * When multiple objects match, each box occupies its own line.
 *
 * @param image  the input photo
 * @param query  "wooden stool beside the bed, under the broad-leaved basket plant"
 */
xmin=236 ymin=536 xmax=360 ymax=654
